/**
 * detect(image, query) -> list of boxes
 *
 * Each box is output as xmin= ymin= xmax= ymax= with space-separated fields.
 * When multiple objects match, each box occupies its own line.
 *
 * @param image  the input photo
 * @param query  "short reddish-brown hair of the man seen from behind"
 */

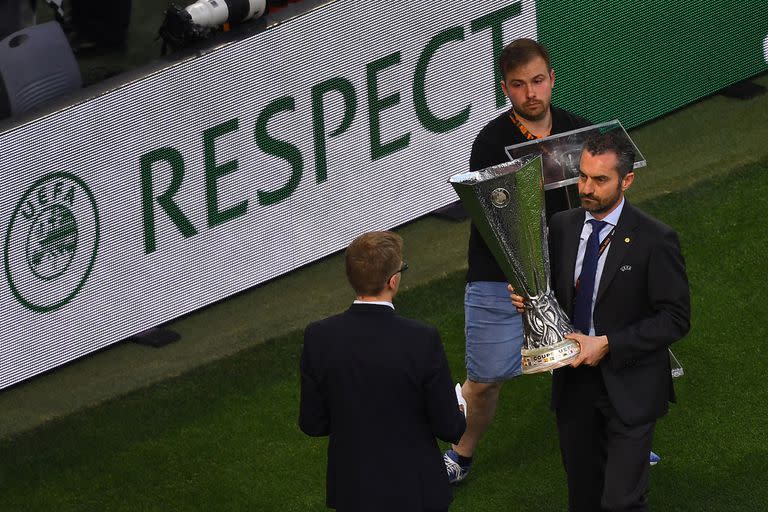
xmin=345 ymin=231 xmax=403 ymax=296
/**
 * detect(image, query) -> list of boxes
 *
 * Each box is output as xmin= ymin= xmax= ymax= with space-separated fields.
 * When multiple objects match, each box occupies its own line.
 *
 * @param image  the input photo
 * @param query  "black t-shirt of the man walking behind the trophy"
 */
xmin=467 ymin=107 xmax=592 ymax=282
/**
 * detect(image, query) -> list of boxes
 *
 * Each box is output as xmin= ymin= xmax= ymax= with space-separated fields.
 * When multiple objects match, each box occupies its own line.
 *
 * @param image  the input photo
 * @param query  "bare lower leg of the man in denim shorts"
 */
xmin=452 ymin=379 xmax=502 ymax=457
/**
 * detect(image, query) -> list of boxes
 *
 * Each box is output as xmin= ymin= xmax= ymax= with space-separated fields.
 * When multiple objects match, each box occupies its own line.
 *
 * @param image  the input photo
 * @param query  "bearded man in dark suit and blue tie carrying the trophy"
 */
xmin=512 ymin=132 xmax=690 ymax=512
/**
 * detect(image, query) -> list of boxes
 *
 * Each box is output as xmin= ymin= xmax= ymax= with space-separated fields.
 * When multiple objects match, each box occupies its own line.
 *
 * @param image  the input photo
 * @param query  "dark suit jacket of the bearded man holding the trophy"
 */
xmin=549 ymin=199 xmax=690 ymax=425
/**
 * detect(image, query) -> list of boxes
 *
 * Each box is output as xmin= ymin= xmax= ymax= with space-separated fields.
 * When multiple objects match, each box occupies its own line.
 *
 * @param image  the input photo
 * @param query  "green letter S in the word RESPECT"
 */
xmin=254 ymin=96 xmax=304 ymax=206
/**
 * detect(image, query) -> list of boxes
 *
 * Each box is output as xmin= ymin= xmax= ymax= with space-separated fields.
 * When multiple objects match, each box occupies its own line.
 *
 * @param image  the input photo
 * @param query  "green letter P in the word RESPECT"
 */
xmin=312 ymin=77 xmax=357 ymax=183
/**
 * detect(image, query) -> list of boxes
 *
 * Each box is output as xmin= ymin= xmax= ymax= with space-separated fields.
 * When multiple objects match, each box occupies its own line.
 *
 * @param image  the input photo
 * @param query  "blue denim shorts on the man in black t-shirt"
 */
xmin=464 ymin=281 xmax=523 ymax=382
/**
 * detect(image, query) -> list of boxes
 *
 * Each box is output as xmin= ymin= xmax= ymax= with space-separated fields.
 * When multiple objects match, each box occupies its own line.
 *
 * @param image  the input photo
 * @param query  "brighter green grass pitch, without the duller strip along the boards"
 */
xmin=0 ymin=154 xmax=768 ymax=512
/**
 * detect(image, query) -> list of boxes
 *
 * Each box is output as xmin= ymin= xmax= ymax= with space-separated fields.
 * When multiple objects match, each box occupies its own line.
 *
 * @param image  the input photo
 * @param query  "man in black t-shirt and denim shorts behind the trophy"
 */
xmin=444 ymin=39 xmax=592 ymax=483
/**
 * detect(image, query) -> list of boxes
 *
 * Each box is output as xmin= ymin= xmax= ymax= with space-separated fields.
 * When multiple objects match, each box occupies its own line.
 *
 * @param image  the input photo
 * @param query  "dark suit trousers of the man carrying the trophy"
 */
xmin=557 ymin=368 xmax=656 ymax=512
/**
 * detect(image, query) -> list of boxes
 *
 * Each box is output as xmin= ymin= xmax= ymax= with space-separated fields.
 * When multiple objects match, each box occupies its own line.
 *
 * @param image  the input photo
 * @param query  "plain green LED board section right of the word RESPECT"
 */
xmin=536 ymin=0 xmax=768 ymax=128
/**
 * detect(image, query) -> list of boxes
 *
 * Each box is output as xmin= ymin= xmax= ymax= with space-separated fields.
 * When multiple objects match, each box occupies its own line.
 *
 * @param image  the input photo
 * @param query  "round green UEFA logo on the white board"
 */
xmin=5 ymin=172 xmax=99 ymax=312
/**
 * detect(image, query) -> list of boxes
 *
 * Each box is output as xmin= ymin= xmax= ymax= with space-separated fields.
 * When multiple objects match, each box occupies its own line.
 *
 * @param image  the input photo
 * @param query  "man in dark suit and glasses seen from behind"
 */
xmin=299 ymin=231 xmax=466 ymax=512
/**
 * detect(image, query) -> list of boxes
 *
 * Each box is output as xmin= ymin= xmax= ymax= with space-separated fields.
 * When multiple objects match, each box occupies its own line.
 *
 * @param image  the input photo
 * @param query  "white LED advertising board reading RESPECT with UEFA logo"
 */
xmin=0 ymin=0 xmax=536 ymax=388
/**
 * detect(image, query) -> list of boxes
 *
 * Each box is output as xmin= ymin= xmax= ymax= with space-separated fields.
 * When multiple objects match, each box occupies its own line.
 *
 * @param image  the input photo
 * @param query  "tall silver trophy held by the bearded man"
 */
xmin=449 ymin=155 xmax=579 ymax=373
